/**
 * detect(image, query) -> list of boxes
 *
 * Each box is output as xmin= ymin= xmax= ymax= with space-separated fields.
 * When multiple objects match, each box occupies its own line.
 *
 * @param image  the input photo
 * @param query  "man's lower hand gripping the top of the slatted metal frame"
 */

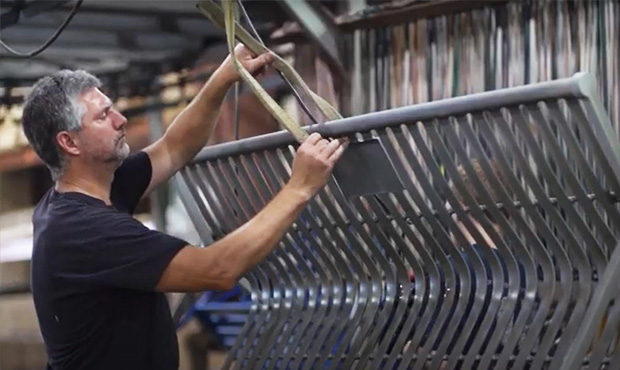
xmin=288 ymin=132 xmax=348 ymax=199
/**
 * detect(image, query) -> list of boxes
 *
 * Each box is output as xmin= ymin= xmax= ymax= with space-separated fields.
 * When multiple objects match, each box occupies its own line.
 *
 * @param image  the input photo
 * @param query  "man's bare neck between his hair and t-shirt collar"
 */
xmin=54 ymin=163 xmax=114 ymax=205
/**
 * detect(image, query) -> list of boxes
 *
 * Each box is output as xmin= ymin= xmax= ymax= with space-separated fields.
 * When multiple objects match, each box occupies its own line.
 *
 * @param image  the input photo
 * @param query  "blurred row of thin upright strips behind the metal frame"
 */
xmin=349 ymin=0 xmax=620 ymax=139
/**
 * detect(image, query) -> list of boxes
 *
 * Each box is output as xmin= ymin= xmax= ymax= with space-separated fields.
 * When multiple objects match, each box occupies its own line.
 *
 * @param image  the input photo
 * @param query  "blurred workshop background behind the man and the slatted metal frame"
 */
xmin=0 ymin=0 xmax=620 ymax=370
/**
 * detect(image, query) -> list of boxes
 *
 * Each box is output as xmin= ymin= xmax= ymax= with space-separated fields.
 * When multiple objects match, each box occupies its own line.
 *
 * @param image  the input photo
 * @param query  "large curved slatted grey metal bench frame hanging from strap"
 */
xmin=182 ymin=75 xmax=620 ymax=369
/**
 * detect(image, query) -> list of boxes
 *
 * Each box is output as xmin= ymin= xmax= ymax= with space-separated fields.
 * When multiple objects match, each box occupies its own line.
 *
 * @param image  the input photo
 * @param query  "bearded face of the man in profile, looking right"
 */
xmin=77 ymin=88 xmax=129 ymax=164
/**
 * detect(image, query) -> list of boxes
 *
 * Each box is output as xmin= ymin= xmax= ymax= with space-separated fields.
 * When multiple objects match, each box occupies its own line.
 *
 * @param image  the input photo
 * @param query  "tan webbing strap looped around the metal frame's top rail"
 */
xmin=198 ymin=0 xmax=342 ymax=142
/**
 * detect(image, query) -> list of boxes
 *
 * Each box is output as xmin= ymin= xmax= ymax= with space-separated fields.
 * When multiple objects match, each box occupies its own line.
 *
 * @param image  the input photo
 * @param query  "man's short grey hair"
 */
xmin=22 ymin=69 xmax=101 ymax=180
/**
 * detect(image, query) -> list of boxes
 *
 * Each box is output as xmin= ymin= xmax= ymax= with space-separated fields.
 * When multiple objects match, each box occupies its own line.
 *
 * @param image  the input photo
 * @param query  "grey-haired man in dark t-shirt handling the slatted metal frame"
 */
xmin=23 ymin=46 xmax=346 ymax=370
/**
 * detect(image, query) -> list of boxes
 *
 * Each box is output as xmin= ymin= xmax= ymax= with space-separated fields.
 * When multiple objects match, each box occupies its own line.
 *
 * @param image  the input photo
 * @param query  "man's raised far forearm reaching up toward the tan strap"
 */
xmin=165 ymin=69 xmax=232 ymax=165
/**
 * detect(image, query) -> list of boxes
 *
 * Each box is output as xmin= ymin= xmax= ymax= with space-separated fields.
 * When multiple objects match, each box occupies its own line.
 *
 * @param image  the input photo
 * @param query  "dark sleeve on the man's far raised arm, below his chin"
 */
xmin=110 ymin=152 xmax=153 ymax=214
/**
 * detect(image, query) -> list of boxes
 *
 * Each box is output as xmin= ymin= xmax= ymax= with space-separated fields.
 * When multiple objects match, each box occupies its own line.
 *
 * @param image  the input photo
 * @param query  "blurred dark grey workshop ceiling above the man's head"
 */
xmin=0 ymin=0 xmax=286 ymax=87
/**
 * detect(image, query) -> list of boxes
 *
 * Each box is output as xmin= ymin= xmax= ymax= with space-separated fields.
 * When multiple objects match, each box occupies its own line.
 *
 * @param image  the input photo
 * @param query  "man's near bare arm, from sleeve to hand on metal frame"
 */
xmin=157 ymin=133 xmax=346 ymax=292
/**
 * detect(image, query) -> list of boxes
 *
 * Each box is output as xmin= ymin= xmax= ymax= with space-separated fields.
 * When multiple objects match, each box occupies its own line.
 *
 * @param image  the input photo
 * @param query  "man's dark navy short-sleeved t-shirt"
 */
xmin=31 ymin=152 xmax=187 ymax=370
